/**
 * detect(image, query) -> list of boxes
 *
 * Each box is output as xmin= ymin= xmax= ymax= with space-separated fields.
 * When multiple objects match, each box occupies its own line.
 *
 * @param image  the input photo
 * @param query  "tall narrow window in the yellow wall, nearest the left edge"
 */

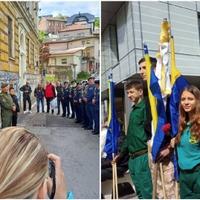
xmin=8 ymin=16 xmax=14 ymax=58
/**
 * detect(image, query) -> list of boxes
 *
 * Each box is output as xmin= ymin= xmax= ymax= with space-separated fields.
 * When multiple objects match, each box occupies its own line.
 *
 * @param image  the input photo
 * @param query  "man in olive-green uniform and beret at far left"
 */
xmin=0 ymin=83 xmax=16 ymax=128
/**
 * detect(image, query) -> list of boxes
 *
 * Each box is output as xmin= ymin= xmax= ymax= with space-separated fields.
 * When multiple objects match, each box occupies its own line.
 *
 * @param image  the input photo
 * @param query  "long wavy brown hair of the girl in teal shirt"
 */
xmin=176 ymin=85 xmax=200 ymax=144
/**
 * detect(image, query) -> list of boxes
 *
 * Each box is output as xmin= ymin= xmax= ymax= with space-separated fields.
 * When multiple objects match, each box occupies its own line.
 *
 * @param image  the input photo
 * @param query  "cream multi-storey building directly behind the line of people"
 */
xmin=45 ymin=35 xmax=99 ymax=80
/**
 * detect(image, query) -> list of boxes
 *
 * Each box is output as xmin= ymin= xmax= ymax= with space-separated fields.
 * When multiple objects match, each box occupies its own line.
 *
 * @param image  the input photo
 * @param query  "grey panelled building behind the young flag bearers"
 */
xmin=101 ymin=1 xmax=200 ymax=128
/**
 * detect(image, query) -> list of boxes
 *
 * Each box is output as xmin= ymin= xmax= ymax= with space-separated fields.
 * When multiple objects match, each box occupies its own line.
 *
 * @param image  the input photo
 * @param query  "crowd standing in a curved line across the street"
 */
xmin=0 ymin=77 xmax=99 ymax=135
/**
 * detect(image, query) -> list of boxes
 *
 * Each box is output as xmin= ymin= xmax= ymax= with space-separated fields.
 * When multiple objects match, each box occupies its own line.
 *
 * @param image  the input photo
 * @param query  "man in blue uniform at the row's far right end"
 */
xmin=92 ymin=80 xmax=99 ymax=135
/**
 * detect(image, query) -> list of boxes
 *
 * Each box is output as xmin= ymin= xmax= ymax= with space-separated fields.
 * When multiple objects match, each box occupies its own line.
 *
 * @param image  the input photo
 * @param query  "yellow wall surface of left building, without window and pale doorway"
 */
xmin=0 ymin=1 xmax=39 ymax=73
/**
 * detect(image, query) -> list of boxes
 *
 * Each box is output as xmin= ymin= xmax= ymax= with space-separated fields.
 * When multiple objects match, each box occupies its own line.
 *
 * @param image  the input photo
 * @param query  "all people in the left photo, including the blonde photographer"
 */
xmin=0 ymin=77 xmax=99 ymax=199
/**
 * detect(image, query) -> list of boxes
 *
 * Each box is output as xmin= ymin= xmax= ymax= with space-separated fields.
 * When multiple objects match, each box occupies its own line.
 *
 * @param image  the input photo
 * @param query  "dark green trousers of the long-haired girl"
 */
xmin=179 ymin=169 xmax=200 ymax=199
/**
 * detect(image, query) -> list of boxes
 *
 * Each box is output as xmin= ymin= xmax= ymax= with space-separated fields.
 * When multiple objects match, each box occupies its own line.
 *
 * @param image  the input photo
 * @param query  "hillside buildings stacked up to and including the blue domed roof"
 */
xmin=41 ymin=13 xmax=100 ymax=81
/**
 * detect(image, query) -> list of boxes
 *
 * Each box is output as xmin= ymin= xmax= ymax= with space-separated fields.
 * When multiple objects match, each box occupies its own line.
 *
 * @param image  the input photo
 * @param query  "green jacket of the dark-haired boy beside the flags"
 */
xmin=121 ymin=99 xmax=147 ymax=154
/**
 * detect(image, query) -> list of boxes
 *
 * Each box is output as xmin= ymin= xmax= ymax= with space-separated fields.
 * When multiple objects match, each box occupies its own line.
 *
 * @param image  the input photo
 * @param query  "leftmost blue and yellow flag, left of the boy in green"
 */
xmin=104 ymin=81 xmax=120 ymax=160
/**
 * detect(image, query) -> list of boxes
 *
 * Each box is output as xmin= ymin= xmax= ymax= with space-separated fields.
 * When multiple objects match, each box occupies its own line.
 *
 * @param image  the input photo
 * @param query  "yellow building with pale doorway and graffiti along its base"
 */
xmin=0 ymin=1 xmax=40 ymax=100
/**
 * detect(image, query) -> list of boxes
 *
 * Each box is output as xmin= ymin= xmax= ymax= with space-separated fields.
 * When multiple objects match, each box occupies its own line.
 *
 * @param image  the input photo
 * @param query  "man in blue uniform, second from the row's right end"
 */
xmin=84 ymin=77 xmax=95 ymax=130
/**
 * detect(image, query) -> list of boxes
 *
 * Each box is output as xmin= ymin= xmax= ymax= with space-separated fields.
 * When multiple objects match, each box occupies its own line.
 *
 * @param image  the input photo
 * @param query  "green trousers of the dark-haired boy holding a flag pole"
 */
xmin=128 ymin=153 xmax=152 ymax=199
